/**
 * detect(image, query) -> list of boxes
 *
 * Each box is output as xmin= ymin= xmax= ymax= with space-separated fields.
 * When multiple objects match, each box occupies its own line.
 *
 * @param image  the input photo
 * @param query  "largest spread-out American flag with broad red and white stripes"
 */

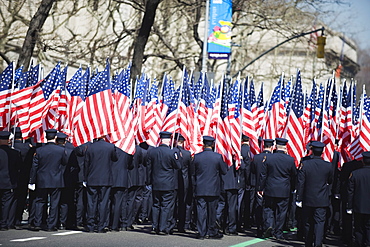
xmin=74 ymin=60 xmax=117 ymax=145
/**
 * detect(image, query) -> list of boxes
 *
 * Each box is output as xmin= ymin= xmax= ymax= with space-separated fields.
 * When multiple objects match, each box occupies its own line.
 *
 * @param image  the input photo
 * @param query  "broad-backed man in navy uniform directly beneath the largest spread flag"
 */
xmin=84 ymin=136 xmax=118 ymax=233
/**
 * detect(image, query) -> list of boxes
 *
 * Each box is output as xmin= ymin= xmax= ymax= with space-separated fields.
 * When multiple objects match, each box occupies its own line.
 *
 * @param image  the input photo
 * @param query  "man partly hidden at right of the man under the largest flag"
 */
xmin=110 ymin=148 xmax=133 ymax=232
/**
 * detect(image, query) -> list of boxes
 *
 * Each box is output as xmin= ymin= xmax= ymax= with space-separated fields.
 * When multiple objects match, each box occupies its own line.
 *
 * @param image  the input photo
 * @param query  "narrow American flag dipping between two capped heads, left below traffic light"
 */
xmin=285 ymin=71 xmax=304 ymax=166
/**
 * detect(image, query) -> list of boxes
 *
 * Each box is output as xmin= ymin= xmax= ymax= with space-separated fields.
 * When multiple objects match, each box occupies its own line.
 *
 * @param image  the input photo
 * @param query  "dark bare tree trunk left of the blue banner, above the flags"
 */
xmin=131 ymin=0 xmax=161 ymax=92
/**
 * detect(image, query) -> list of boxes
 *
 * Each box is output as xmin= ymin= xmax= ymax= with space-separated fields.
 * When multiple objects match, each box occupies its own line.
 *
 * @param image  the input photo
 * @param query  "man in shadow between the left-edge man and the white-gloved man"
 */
xmin=11 ymin=127 xmax=35 ymax=229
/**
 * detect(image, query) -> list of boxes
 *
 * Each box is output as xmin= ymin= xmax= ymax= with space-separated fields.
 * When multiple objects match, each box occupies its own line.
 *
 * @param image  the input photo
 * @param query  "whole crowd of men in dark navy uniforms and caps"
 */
xmin=0 ymin=128 xmax=370 ymax=246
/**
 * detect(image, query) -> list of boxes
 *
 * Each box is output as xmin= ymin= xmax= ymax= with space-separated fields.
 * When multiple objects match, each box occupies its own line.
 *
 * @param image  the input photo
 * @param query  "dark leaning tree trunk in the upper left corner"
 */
xmin=17 ymin=0 xmax=55 ymax=70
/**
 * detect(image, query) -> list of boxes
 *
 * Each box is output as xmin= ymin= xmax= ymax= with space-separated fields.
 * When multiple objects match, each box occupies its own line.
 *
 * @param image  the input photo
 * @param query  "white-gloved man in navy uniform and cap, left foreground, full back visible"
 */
xmin=29 ymin=129 xmax=66 ymax=231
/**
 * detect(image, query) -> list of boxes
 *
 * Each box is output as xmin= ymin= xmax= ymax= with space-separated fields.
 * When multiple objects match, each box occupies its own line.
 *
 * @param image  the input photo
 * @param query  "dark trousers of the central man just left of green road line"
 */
xmin=196 ymin=196 xmax=219 ymax=237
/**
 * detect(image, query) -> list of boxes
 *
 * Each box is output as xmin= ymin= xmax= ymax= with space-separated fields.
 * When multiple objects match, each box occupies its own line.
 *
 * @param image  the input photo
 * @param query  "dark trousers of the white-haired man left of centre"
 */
xmin=152 ymin=190 xmax=174 ymax=232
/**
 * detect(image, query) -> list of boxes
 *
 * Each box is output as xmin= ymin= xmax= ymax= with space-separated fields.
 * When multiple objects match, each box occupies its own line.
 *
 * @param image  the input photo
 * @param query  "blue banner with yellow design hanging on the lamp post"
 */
xmin=207 ymin=0 xmax=232 ymax=59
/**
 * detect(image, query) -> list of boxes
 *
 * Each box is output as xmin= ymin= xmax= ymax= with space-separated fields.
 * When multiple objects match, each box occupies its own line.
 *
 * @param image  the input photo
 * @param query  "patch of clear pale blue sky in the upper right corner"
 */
xmin=323 ymin=0 xmax=370 ymax=49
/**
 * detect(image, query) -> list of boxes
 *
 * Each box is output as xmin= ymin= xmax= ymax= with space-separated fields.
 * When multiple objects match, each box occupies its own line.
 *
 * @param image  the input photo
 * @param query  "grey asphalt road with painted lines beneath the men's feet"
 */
xmin=0 ymin=225 xmax=342 ymax=247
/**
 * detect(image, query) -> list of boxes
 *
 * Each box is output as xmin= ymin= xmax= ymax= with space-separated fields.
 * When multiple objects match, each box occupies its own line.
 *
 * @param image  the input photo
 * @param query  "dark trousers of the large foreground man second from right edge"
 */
xmin=303 ymin=206 xmax=327 ymax=247
